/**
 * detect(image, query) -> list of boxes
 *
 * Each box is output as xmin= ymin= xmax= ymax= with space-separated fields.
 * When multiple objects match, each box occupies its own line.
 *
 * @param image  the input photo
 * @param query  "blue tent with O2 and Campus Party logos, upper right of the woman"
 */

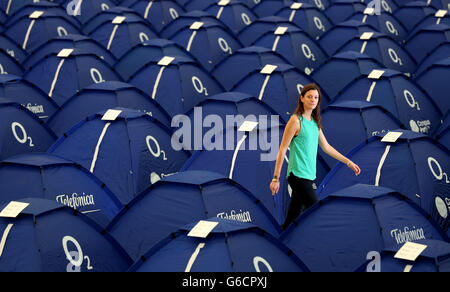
xmin=335 ymin=69 xmax=442 ymax=134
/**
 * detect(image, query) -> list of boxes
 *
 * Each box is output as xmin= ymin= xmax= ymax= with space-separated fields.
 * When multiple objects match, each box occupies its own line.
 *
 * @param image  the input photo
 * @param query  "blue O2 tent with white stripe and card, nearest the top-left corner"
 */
xmin=4 ymin=10 xmax=80 ymax=54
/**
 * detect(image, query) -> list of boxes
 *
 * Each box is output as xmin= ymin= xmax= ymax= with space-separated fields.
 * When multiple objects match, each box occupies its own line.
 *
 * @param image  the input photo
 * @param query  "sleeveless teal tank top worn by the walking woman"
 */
xmin=287 ymin=116 xmax=319 ymax=180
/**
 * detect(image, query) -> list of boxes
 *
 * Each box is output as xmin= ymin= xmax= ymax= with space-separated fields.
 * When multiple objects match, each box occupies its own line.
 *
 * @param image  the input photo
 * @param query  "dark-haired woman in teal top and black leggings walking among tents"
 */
xmin=270 ymin=84 xmax=361 ymax=230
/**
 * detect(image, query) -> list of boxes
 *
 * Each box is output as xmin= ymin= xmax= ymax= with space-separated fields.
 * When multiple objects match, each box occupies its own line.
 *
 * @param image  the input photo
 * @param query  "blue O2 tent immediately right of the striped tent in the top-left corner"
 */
xmin=89 ymin=16 xmax=158 ymax=59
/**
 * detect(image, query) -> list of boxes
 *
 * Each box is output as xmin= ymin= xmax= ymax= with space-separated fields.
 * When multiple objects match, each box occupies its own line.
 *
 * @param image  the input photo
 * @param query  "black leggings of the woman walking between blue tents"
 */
xmin=281 ymin=173 xmax=318 ymax=230
